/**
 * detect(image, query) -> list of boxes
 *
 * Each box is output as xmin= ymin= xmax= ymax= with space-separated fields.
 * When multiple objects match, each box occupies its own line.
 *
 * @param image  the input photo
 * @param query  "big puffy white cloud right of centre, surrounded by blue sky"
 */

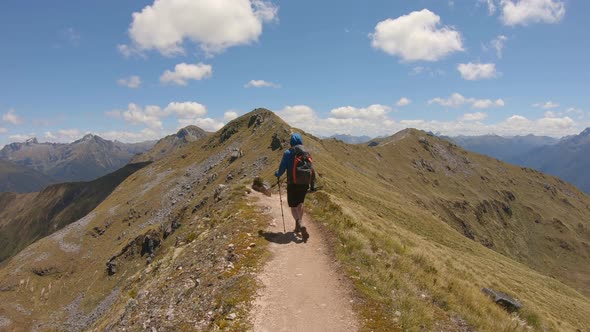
xmin=369 ymin=9 xmax=463 ymax=61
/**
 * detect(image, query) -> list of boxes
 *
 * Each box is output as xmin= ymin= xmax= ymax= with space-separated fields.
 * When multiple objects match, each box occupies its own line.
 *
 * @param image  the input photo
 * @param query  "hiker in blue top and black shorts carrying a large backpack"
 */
xmin=275 ymin=133 xmax=315 ymax=237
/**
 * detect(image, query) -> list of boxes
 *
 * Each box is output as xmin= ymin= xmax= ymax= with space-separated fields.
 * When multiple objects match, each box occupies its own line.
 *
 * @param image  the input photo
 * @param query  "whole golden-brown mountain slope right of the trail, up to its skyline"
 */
xmin=314 ymin=130 xmax=590 ymax=330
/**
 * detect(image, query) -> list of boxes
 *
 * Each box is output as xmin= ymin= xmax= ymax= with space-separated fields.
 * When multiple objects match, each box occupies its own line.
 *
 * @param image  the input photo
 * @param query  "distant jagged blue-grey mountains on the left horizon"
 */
xmin=0 ymin=134 xmax=152 ymax=183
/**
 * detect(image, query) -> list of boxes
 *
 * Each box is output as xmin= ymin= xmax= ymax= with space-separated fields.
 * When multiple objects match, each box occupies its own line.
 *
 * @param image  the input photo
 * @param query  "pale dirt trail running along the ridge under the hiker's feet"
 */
xmin=252 ymin=193 xmax=358 ymax=332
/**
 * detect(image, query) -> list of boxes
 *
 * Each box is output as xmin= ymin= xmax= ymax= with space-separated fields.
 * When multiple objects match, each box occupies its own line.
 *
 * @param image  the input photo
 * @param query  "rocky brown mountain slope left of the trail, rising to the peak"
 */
xmin=0 ymin=111 xmax=289 ymax=331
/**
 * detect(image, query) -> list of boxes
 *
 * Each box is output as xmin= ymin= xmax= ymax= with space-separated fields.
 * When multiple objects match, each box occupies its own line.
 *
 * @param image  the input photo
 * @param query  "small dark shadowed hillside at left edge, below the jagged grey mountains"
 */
xmin=0 ymin=160 xmax=51 ymax=193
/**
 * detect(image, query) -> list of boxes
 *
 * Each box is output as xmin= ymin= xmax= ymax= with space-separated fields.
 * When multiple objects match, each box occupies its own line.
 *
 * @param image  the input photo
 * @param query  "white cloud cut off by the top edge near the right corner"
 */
xmin=501 ymin=0 xmax=565 ymax=26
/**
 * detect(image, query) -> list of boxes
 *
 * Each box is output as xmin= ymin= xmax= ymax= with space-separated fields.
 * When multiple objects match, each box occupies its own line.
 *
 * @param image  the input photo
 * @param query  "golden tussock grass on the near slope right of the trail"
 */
xmin=307 ymin=130 xmax=590 ymax=331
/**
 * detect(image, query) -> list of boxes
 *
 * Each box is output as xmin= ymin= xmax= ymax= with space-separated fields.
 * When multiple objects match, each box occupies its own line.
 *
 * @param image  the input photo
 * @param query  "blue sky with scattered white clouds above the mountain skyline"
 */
xmin=0 ymin=0 xmax=590 ymax=144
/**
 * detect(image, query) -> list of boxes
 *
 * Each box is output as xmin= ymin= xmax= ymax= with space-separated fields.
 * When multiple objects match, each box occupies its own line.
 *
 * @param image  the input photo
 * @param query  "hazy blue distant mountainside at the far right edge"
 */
xmin=511 ymin=128 xmax=590 ymax=193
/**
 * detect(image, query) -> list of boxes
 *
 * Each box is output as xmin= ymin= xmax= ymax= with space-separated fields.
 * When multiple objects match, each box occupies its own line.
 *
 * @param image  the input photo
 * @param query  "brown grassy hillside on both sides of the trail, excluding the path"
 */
xmin=0 ymin=109 xmax=590 ymax=331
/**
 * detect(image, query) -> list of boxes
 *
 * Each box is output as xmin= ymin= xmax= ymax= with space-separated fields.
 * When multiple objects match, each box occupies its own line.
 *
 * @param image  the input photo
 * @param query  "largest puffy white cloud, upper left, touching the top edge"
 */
xmin=129 ymin=0 xmax=278 ymax=56
